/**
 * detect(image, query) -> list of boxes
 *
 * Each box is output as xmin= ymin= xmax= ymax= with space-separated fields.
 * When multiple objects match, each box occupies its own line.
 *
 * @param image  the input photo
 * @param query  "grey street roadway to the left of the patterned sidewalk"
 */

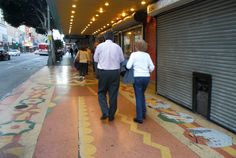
xmin=0 ymin=53 xmax=48 ymax=100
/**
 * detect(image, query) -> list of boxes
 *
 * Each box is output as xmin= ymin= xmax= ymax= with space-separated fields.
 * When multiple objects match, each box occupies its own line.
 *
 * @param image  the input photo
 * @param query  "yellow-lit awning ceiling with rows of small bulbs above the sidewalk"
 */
xmin=49 ymin=0 xmax=153 ymax=35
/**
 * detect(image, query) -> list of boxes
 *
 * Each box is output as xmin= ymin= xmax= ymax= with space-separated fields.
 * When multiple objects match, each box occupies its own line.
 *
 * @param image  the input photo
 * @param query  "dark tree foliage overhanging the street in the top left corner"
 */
xmin=0 ymin=0 xmax=54 ymax=34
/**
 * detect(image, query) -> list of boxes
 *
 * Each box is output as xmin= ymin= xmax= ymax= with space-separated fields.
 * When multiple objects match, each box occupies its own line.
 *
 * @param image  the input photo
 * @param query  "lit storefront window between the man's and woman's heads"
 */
xmin=123 ymin=27 xmax=143 ymax=56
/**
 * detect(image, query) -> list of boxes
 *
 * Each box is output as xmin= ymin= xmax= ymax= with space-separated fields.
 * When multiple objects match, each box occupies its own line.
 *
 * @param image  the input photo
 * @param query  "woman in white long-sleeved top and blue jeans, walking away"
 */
xmin=126 ymin=40 xmax=155 ymax=123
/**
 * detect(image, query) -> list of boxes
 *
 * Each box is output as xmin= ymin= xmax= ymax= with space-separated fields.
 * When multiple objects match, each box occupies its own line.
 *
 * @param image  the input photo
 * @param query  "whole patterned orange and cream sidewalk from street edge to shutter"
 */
xmin=0 ymin=54 xmax=236 ymax=158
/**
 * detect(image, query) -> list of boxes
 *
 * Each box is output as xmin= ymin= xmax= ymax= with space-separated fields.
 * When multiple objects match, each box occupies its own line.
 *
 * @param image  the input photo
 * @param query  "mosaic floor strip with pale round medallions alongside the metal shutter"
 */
xmin=121 ymin=85 xmax=236 ymax=158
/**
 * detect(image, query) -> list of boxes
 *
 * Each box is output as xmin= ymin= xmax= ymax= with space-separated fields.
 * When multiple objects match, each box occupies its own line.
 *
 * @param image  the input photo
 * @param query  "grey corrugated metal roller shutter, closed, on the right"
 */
xmin=157 ymin=0 xmax=236 ymax=131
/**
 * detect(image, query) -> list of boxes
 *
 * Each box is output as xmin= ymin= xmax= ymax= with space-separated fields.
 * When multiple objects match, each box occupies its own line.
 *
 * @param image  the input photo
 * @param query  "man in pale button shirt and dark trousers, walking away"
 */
xmin=94 ymin=32 xmax=124 ymax=121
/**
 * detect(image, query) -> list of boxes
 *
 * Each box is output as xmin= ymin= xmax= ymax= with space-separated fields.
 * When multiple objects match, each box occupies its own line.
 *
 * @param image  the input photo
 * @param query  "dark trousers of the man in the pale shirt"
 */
xmin=98 ymin=69 xmax=120 ymax=120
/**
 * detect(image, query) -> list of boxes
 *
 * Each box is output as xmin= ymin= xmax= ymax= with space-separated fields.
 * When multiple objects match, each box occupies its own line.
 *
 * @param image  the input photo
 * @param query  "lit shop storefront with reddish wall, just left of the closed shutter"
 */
xmin=112 ymin=11 xmax=157 ymax=82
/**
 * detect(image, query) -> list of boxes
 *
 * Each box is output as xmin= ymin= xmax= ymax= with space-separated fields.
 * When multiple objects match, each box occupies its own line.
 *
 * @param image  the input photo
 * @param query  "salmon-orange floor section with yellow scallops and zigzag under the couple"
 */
xmin=78 ymin=89 xmax=198 ymax=158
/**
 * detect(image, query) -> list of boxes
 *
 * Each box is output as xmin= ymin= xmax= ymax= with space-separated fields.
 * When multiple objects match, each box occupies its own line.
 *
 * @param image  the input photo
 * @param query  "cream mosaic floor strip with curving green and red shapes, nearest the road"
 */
xmin=0 ymin=84 xmax=54 ymax=158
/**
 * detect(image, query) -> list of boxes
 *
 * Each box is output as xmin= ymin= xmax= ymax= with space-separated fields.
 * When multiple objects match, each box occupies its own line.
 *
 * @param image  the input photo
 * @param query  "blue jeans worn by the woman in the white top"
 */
xmin=133 ymin=77 xmax=150 ymax=121
